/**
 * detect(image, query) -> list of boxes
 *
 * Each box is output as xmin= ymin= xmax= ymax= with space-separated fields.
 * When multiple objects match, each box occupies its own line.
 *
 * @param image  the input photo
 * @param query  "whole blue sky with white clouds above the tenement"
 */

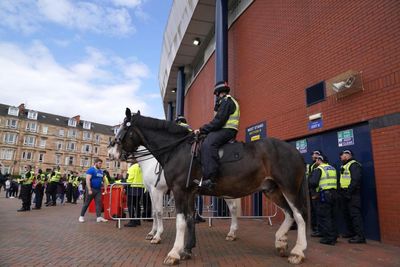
xmin=0 ymin=0 xmax=173 ymax=125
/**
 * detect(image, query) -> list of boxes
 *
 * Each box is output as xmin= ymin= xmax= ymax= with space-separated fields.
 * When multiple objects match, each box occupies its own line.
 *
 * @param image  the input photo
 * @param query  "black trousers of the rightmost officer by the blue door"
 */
xmin=340 ymin=190 xmax=365 ymax=238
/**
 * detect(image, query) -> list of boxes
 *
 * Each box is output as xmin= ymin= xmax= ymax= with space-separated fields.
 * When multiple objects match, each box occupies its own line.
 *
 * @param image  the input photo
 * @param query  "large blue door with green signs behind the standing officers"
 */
xmin=290 ymin=123 xmax=380 ymax=240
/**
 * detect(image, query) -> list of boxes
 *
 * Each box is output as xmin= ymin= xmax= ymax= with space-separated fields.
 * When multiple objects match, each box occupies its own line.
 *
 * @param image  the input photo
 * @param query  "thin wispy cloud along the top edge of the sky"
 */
xmin=0 ymin=0 xmax=143 ymax=36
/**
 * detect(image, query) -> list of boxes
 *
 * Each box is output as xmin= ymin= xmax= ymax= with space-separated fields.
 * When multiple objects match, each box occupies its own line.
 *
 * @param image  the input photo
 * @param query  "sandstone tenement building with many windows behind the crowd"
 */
xmin=0 ymin=104 xmax=127 ymax=176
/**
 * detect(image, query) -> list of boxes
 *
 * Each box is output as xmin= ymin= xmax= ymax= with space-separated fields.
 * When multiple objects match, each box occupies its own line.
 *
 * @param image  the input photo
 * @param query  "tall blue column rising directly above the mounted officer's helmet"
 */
xmin=215 ymin=0 xmax=228 ymax=84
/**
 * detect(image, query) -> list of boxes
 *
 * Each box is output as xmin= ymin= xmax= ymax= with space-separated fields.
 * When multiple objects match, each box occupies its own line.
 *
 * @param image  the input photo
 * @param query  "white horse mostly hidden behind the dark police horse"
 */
xmin=138 ymin=152 xmax=238 ymax=244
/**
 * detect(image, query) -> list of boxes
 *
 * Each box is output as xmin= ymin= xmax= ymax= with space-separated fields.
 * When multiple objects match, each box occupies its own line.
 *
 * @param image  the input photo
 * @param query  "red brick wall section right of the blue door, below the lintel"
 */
xmin=371 ymin=125 xmax=400 ymax=246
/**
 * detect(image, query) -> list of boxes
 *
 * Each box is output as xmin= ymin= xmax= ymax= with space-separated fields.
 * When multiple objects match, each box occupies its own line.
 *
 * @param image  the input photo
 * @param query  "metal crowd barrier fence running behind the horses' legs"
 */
xmin=100 ymin=183 xmax=278 ymax=228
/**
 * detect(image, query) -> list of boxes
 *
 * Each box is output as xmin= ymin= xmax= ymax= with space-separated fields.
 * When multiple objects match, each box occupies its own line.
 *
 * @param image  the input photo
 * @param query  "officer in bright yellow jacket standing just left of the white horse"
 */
xmin=124 ymin=159 xmax=144 ymax=227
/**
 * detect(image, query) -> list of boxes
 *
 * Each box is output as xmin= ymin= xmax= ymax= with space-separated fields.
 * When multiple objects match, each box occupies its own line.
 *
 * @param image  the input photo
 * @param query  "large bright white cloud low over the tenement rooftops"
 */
xmin=0 ymin=41 xmax=158 ymax=125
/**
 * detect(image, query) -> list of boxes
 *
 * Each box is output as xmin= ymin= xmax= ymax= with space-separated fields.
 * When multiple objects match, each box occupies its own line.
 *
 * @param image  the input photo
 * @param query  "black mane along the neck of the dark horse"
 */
xmin=133 ymin=114 xmax=189 ymax=135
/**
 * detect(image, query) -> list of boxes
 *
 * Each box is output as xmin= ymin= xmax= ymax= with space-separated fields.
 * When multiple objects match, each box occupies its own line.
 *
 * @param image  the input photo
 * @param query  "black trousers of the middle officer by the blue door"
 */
xmin=318 ymin=190 xmax=338 ymax=241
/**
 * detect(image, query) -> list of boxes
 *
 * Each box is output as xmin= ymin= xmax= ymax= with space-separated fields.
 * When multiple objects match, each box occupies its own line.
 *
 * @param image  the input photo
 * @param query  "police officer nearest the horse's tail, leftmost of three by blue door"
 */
xmin=306 ymin=150 xmax=322 ymax=237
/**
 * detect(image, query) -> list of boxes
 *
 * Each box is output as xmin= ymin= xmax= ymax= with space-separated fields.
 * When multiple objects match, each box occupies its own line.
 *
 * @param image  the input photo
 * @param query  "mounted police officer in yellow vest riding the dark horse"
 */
xmin=195 ymin=83 xmax=240 ymax=190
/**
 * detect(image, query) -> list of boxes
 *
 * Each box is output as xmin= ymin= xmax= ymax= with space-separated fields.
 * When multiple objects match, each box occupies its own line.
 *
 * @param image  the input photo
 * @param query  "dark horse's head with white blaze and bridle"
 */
xmin=108 ymin=108 xmax=143 ymax=160
